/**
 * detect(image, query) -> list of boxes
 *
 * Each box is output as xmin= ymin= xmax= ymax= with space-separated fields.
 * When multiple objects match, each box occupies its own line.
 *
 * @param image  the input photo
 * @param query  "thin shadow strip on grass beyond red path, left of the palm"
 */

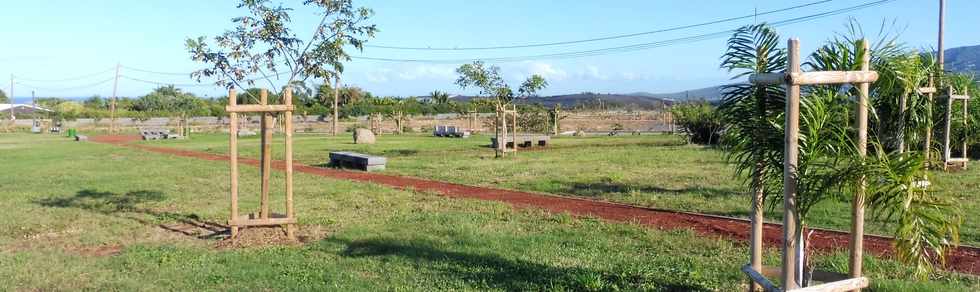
xmin=559 ymin=181 xmax=739 ymax=198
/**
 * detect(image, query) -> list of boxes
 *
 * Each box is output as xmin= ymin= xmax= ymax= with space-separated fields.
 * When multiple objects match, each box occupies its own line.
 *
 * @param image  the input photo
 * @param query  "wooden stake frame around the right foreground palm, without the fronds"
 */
xmin=742 ymin=38 xmax=878 ymax=291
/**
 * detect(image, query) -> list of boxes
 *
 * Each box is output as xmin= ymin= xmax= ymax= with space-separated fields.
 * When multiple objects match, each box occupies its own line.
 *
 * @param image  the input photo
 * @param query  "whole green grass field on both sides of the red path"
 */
xmin=0 ymin=134 xmax=980 ymax=291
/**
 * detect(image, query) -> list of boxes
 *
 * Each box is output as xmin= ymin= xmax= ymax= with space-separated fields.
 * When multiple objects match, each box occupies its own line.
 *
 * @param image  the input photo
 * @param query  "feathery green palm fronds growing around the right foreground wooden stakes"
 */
xmin=721 ymin=21 xmax=959 ymax=282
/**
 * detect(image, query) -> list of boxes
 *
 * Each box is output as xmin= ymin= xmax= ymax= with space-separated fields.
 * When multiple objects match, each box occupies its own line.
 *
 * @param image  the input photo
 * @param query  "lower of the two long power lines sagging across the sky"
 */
xmin=351 ymin=0 xmax=896 ymax=63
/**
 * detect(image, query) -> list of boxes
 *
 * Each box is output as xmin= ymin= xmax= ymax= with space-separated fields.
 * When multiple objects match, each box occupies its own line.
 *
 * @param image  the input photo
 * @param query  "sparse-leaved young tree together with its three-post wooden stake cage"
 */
xmin=186 ymin=0 xmax=377 ymax=239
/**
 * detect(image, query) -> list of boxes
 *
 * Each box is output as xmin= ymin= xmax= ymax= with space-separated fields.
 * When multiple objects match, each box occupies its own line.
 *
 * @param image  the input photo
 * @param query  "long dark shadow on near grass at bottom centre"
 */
xmin=324 ymin=238 xmax=711 ymax=291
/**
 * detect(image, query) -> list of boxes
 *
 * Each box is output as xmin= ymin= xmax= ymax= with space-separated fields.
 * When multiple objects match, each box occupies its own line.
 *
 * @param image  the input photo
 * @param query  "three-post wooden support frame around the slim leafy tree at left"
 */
xmin=226 ymin=88 xmax=296 ymax=240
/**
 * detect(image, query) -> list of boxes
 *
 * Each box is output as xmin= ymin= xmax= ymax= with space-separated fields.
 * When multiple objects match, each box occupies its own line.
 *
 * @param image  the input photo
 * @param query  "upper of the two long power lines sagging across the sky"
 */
xmin=364 ymin=0 xmax=833 ymax=51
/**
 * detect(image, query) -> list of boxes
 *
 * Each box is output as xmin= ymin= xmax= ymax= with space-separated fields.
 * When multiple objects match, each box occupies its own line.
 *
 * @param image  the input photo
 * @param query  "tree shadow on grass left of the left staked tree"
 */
xmin=34 ymin=189 xmax=229 ymax=239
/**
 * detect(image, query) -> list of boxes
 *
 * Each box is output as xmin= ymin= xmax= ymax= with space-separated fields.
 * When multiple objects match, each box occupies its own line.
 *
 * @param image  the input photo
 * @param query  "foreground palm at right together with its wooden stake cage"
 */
xmin=721 ymin=25 xmax=958 ymax=291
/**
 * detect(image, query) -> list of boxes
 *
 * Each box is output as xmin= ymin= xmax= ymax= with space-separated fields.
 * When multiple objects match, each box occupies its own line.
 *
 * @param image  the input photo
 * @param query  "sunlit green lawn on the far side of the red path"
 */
xmin=149 ymin=134 xmax=980 ymax=246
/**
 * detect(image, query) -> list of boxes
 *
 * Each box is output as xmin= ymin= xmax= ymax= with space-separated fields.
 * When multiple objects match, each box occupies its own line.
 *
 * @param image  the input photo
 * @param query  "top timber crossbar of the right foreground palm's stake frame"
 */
xmin=749 ymin=71 xmax=878 ymax=85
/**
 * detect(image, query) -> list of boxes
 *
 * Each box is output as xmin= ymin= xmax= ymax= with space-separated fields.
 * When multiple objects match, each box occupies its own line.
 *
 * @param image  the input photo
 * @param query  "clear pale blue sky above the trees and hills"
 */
xmin=0 ymin=0 xmax=980 ymax=97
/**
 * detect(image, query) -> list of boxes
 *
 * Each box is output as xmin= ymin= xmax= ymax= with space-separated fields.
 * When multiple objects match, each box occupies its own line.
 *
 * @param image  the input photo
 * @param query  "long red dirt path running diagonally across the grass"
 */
xmin=92 ymin=136 xmax=980 ymax=275
